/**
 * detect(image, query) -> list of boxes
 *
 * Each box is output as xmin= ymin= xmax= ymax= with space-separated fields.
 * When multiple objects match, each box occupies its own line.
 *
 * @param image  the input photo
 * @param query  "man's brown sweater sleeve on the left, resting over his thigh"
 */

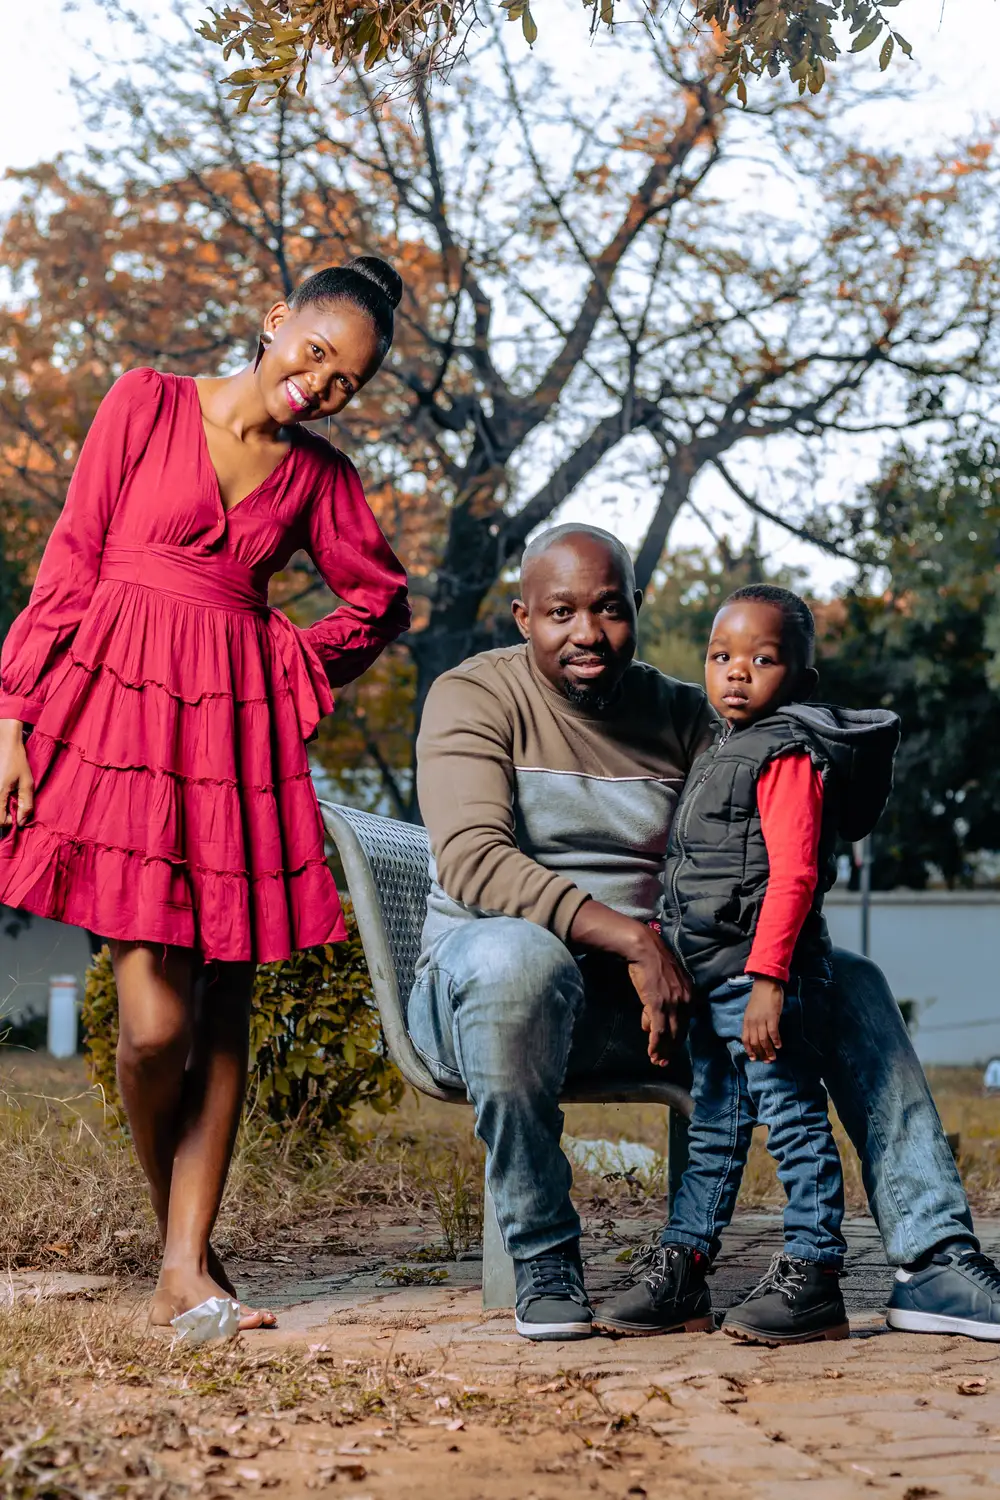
xmin=417 ymin=669 xmax=588 ymax=942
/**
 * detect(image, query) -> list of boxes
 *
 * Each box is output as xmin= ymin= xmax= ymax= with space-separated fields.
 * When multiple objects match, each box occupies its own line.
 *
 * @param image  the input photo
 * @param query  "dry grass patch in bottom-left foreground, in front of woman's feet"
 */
xmin=0 ymin=1299 xmax=434 ymax=1500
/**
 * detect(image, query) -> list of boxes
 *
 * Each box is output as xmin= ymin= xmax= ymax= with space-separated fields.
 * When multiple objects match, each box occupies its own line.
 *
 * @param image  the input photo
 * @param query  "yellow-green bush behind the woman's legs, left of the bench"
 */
xmin=82 ymin=906 xmax=403 ymax=1136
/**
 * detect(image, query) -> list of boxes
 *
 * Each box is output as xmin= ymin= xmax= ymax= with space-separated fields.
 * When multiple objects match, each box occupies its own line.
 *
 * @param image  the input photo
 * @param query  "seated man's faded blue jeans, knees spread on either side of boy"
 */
xmin=406 ymin=917 xmax=976 ymax=1265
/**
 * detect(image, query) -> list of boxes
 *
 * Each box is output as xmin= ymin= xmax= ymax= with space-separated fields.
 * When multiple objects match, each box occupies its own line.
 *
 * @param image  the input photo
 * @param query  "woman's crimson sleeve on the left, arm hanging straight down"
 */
xmin=0 ymin=369 xmax=162 ymax=725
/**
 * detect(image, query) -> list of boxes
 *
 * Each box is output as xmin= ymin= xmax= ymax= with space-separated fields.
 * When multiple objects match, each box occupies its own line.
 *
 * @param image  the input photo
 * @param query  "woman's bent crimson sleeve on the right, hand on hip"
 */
xmin=303 ymin=453 xmax=409 ymax=687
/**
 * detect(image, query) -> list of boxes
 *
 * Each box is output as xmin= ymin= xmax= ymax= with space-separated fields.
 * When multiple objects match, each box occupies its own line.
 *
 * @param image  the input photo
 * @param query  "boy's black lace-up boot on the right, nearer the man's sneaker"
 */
xmin=723 ymin=1254 xmax=850 ymax=1344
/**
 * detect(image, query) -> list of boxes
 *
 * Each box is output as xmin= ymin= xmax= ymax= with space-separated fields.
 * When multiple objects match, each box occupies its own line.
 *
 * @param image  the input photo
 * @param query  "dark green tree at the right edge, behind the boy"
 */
xmin=820 ymin=432 xmax=1000 ymax=888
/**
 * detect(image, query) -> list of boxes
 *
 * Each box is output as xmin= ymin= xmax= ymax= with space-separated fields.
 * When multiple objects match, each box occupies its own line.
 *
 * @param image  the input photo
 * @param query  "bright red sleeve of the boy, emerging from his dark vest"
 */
xmin=747 ymin=755 xmax=823 ymax=980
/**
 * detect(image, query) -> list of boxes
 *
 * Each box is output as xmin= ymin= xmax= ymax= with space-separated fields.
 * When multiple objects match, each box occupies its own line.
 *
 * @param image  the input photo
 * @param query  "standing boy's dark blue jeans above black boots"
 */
xmin=663 ymin=965 xmax=847 ymax=1271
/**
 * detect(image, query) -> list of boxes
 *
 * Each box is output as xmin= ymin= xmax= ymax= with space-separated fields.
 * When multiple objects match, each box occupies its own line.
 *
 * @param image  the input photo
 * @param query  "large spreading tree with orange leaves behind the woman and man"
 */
xmin=0 ymin=5 xmax=1000 ymax=813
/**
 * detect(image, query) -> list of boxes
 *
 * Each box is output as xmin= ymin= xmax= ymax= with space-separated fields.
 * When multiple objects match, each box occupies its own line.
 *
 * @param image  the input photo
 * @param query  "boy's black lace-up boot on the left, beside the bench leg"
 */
xmin=594 ymin=1245 xmax=715 ymax=1334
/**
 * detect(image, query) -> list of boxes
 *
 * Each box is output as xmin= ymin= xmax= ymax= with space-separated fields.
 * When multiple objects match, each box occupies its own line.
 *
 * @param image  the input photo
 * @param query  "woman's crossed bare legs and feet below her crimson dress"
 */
xmin=114 ymin=944 xmax=273 ymax=1328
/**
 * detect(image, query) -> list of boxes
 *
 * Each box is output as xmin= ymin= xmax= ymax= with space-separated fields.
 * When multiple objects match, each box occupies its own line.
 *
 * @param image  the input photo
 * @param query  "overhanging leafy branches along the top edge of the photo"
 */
xmin=199 ymin=0 xmax=912 ymax=110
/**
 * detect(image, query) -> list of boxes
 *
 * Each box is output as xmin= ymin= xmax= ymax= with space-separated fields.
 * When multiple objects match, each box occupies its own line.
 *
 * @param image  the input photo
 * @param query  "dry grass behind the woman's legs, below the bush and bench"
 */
xmin=0 ymin=1049 xmax=481 ymax=1277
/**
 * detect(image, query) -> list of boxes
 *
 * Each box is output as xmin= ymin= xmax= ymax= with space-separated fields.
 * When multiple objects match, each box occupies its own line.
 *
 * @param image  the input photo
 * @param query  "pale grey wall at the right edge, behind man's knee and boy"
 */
xmin=825 ymin=890 xmax=1000 ymax=1067
